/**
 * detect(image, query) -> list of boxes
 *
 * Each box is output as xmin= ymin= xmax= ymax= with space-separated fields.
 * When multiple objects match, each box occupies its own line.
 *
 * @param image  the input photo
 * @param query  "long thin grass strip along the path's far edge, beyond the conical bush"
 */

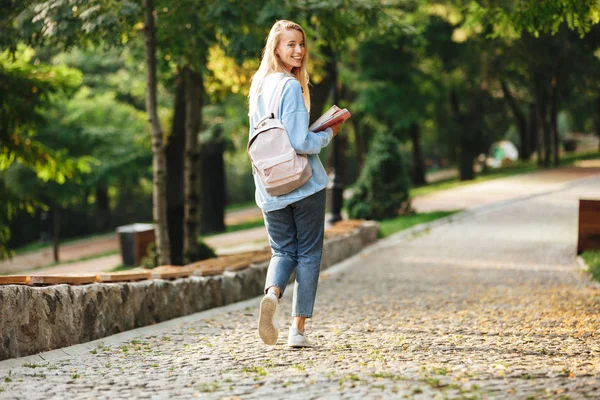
xmin=410 ymin=150 xmax=600 ymax=197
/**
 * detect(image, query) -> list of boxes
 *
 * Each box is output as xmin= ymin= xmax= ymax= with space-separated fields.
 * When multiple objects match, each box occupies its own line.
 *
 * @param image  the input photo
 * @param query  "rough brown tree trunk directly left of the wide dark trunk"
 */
xmin=183 ymin=68 xmax=203 ymax=262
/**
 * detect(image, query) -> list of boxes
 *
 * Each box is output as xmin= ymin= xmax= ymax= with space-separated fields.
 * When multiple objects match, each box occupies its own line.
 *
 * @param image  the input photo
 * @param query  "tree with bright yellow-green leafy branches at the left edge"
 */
xmin=0 ymin=46 xmax=88 ymax=258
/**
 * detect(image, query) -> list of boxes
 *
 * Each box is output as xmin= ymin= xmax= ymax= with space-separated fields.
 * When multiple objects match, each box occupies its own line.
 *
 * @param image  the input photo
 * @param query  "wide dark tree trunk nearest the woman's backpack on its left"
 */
xmin=200 ymin=126 xmax=227 ymax=235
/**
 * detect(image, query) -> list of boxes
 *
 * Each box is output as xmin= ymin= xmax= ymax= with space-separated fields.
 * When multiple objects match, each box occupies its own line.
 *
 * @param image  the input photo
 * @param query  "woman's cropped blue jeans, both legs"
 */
xmin=263 ymin=190 xmax=325 ymax=318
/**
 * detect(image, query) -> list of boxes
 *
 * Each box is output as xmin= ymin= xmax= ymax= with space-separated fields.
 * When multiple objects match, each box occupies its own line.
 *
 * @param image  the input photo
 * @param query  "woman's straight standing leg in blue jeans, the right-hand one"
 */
xmin=291 ymin=190 xmax=325 ymax=322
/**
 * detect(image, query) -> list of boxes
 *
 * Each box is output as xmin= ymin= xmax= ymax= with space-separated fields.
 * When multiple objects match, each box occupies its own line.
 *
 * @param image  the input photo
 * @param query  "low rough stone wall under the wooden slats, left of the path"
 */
xmin=0 ymin=222 xmax=378 ymax=360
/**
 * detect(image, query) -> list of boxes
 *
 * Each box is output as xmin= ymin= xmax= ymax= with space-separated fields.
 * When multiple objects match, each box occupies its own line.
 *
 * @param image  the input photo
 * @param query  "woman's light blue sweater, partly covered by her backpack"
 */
xmin=249 ymin=73 xmax=333 ymax=212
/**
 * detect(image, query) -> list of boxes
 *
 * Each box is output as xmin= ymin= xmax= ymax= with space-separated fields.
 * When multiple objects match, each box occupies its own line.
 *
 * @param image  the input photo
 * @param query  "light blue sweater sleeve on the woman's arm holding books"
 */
xmin=279 ymin=79 xmax=333 ymax=154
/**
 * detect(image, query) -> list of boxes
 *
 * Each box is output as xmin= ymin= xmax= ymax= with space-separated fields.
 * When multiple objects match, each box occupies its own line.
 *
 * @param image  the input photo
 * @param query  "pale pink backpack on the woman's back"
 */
xmin=248 ymin=77 xmax=312 ymax=196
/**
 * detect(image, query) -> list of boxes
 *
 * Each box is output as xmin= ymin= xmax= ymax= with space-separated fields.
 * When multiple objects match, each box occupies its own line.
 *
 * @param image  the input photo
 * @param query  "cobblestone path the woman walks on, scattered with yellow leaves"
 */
xmin=0 ymin=179 xmax=600 ymax=399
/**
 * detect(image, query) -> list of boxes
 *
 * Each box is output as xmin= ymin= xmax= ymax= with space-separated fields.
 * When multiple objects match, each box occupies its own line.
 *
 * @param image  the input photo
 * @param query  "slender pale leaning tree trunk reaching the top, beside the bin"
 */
xmin=143 ymin=0 xmax=171 ymax=265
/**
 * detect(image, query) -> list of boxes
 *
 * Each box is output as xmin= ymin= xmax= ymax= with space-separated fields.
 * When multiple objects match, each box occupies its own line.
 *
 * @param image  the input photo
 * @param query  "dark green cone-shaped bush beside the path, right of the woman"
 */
xmin=348 ymin=134 xmax=409 ymax=220
